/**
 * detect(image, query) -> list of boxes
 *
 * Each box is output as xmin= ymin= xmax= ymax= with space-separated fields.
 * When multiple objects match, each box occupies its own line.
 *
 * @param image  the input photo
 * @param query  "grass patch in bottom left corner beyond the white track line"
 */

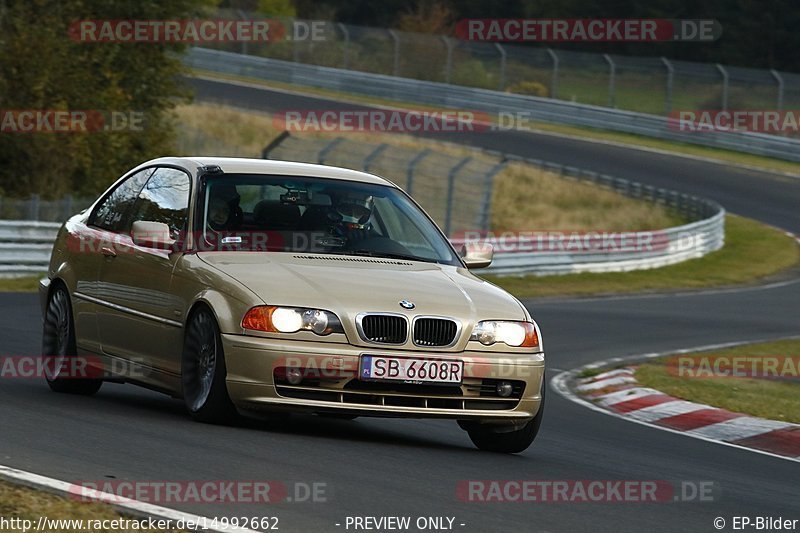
xmin=0 ymin=481 xmax=184 ymax=533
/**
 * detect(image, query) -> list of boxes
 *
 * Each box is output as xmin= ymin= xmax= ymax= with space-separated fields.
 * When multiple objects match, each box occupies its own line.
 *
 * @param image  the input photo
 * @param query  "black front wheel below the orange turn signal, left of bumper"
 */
xmin=181 ymin=307 xmax=238 ymax=424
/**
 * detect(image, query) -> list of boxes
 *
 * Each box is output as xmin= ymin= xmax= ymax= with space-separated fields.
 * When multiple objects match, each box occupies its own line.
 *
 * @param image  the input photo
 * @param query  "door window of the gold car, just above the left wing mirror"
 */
xmin=127 ymin=167 xmax=191 ymax=233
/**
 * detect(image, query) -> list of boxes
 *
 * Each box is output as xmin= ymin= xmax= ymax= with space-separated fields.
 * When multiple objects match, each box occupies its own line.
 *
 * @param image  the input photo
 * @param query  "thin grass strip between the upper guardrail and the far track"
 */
xmin=195 ymin=71 xmax=800 ymax=174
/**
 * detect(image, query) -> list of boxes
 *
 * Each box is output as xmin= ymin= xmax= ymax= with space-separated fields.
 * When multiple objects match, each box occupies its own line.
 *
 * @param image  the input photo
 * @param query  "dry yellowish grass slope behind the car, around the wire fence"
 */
xmin=176 ymin=104 xmax=682 ymax=231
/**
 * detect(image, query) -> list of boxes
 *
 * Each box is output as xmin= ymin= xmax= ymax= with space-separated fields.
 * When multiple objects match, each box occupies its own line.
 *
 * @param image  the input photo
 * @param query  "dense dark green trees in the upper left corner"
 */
xmin=0 ymin=0 xmax=216 ymax=197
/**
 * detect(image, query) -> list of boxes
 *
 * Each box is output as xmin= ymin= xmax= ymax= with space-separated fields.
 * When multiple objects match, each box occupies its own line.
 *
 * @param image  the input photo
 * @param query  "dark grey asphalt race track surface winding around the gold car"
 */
xmin=0 ymin=77 xmax=800 ymax=532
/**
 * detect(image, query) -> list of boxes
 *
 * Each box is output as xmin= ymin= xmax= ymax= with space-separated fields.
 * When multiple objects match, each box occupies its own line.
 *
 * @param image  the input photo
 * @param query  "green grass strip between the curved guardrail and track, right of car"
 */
xmin=485 ymin=215 xmax=800 ymax=298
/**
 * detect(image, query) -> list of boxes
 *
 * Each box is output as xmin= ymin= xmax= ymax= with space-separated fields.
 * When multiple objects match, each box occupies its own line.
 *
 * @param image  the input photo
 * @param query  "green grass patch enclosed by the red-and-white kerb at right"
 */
xmin=636 ymin=339 xmax=800 ymax=423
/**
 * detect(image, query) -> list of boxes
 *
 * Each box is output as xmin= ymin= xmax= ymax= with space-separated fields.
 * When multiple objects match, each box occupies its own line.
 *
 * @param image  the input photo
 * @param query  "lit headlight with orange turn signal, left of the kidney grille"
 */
xmin=242 ymin=305 xmax=344 ymax=335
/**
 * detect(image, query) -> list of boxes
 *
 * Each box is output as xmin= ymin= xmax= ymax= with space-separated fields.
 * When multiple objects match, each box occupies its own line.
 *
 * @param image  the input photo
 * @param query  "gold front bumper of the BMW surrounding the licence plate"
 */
xmin=222 ymin=335 xmax=544 ymax=425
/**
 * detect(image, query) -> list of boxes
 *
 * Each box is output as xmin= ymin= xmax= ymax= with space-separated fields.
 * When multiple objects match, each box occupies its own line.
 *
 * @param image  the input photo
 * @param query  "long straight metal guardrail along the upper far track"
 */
xmin=184 ymin=48 xmax=800 ymax=161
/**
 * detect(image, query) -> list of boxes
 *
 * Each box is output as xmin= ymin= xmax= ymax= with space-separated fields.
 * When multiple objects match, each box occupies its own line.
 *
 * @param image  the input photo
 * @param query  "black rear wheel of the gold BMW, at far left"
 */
xmin=42 ymin=285 xmax=103 ymax=396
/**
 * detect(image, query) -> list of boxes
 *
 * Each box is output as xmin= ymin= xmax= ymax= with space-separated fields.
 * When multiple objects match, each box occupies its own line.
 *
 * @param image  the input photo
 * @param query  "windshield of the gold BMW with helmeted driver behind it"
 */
xmin=198 ymin=174 xmax=461 ymax=266
